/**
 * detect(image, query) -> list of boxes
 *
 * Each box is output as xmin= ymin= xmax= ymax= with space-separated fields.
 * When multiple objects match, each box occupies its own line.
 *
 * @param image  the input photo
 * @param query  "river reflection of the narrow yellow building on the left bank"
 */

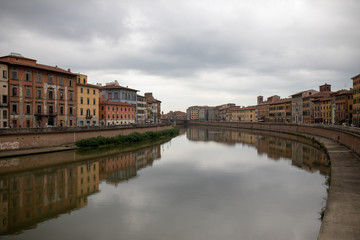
xmin=77 ymin=162 xmax=99 ymax=208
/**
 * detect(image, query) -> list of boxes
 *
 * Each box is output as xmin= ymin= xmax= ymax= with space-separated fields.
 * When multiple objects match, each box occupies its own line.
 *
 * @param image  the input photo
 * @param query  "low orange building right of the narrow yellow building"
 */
xmin=99 ymin=98 xmax=136 ymax=125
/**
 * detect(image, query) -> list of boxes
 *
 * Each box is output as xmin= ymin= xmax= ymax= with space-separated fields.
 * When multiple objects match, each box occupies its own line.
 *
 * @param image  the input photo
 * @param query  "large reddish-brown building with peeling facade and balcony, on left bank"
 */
xmin=0 ymin=53 xmax=76 ymax=128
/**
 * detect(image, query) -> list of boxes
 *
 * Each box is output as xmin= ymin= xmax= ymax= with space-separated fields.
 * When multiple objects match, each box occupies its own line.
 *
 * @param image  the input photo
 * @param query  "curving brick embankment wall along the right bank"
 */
xmin=187 ymin=121 xmax=360 ymax=155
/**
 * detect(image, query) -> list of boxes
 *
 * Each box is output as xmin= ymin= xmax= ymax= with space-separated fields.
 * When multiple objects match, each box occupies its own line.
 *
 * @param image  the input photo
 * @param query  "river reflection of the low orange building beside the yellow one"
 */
xmin=100 ymin=152 xmax=136 ymax=185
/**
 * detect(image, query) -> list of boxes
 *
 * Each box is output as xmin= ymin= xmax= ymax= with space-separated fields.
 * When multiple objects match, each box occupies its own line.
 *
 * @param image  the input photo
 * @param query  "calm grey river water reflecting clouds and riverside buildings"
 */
xmin=0 ymin=128 xmax=329 ymax=240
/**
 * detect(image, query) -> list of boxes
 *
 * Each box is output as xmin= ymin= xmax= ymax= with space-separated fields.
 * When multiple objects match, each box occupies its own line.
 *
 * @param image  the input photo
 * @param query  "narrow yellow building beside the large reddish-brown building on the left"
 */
xmin=76 ymin=74 xmax=99 ymax=127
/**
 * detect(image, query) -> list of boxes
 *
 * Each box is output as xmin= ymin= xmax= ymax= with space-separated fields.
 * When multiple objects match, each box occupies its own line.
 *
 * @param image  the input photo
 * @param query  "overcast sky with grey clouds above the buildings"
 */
xmin=0 ymin=0 xmax=360 ymax=113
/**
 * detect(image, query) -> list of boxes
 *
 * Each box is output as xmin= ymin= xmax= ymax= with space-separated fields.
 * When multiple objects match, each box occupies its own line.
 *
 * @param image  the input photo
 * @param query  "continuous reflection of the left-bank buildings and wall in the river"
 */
xmin=0 ymin=145 xmax=161 ymax=235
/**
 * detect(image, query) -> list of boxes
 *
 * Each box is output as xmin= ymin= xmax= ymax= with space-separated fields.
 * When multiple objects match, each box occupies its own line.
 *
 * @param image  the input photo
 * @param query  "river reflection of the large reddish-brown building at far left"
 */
xmin=0 ymin=166 xmax=77 ymax=234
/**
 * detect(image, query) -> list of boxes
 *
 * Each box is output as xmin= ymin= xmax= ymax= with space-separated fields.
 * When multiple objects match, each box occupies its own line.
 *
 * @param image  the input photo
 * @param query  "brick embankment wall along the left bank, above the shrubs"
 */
xmin=0 ymin=124 xmax=172 ymax=151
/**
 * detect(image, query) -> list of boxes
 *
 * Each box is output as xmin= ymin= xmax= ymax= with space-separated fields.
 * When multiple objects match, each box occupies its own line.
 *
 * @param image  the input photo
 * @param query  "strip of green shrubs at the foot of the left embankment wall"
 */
xmin=75 ymin=128 xmax=179 ymax=148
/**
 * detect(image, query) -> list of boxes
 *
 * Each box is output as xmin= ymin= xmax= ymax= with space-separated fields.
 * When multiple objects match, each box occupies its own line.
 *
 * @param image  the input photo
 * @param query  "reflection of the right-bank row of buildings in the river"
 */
xmin=186 ymin=127 xmax=330 ymax=175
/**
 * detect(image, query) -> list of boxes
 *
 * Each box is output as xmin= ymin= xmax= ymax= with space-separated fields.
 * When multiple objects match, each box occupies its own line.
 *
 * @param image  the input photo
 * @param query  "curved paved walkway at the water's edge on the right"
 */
xmin=318 ymin=138 xmax=360 ymax=240
